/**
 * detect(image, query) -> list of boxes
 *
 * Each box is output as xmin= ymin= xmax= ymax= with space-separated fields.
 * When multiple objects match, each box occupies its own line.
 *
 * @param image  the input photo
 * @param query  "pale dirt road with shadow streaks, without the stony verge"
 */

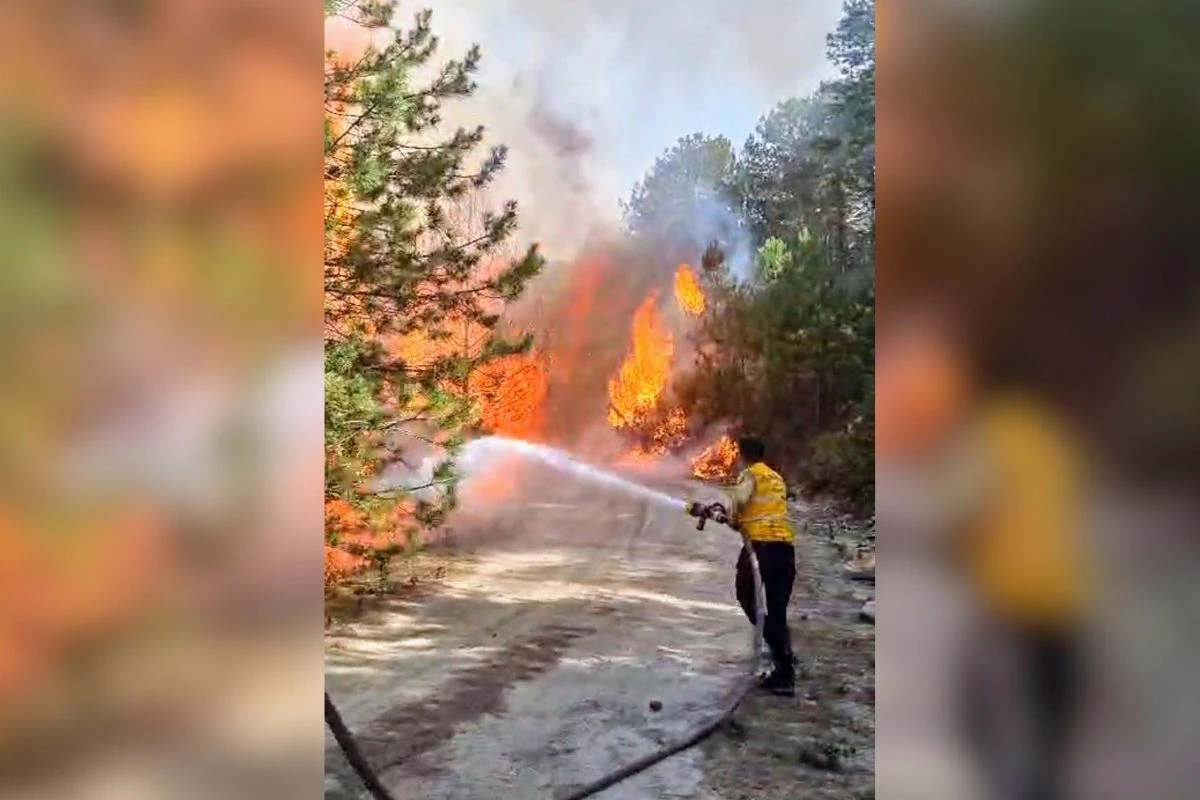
xmin=325 ymin=465 xmax=878 ymax=800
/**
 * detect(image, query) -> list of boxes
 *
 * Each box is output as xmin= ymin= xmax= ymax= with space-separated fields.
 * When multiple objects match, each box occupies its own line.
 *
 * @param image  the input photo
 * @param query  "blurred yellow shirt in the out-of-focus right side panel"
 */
xmin=965 ymin=398 xmax=1087 ymax=627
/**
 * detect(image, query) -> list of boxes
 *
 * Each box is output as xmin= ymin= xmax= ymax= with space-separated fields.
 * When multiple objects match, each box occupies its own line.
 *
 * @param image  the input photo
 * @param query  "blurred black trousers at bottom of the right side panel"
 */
xmin=965 ymin=621 xmax=1082 ymax=800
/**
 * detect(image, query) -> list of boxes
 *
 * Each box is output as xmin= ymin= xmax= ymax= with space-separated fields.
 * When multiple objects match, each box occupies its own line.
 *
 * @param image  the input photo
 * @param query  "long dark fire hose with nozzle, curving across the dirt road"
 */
xmin=325 ymin=503 xmax=767 ymax=800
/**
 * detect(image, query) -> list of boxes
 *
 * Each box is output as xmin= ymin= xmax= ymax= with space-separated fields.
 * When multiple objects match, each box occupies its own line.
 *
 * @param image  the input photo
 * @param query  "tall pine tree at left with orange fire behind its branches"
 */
xmin=324 ymin=0 xmax=541 ymax=585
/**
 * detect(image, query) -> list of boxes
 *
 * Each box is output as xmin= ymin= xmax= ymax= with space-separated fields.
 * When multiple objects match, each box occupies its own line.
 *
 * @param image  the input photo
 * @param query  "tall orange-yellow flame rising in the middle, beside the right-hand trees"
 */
xmin=608 ymin=291 xmax=674 ymax=431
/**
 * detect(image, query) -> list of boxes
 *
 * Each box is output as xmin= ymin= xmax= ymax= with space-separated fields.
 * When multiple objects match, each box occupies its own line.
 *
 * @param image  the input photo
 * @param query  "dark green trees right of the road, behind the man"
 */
xmin=662 ymin=0 xmax=875 ymax=510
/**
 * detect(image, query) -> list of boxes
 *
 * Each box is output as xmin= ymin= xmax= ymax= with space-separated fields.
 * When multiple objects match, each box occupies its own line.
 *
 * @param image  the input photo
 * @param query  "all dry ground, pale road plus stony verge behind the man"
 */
xmin=325 ymin=476 xmax=874 ymax=800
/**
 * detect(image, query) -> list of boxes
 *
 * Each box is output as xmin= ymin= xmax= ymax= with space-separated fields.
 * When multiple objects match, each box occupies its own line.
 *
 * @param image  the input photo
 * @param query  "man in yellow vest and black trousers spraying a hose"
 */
xmin=688 ymin=437 xmax=796 ymax=697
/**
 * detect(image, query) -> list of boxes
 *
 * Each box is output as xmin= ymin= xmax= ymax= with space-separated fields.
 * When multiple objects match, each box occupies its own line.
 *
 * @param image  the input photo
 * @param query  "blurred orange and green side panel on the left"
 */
xmin=0 ymin=0 xmax=323 ymax=798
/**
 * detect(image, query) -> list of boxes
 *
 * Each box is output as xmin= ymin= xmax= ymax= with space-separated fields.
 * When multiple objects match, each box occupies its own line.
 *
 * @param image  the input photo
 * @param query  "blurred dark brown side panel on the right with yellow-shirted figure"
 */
xmin=876 ymin=0 xmax=1200 ymax=799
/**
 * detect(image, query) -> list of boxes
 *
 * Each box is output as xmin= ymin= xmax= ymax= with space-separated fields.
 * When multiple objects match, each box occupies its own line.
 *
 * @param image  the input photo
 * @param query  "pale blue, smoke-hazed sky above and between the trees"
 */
xmin=324 ymin=0 xmax=841 ymax=258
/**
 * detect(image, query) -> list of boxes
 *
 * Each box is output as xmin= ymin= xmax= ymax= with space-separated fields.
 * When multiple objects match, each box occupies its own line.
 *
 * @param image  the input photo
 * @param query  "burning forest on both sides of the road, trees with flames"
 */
xmin=324 ymin=0 xmax=875 ymax=582
